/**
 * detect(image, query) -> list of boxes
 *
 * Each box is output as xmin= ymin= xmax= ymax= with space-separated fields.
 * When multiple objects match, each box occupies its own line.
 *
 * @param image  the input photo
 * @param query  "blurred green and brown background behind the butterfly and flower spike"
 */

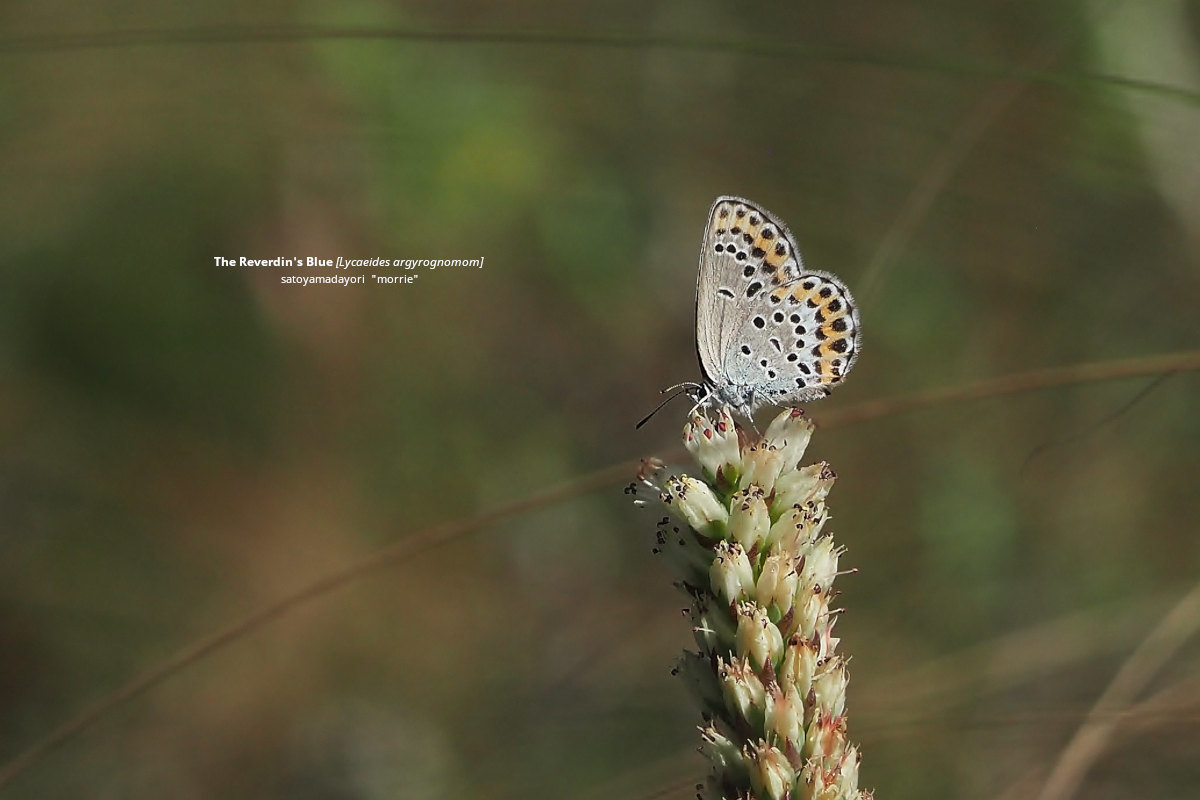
xmin=0 ymin=0 xmax=1200 ymax=800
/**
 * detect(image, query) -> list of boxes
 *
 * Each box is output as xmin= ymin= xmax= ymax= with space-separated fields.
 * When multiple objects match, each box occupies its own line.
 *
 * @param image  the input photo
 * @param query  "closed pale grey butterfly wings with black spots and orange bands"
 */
xmin=696 ymin=197 xmax=859 ymax=409
